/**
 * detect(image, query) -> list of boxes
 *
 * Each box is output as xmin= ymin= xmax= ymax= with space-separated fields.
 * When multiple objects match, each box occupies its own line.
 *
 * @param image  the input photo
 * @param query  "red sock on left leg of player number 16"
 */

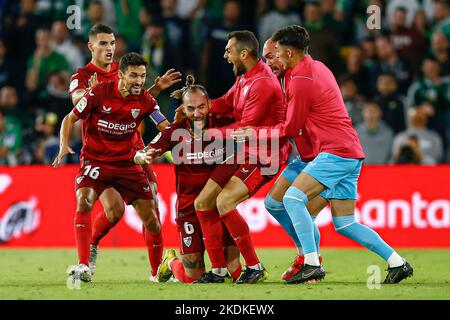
xmin=74 ymin=211 xmax=92 ymax=266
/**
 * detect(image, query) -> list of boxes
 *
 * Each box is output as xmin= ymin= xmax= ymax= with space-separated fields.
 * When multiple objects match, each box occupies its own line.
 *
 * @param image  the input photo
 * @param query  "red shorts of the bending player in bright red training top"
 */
xmin=210 ymin=164 xmax=278 ymax=197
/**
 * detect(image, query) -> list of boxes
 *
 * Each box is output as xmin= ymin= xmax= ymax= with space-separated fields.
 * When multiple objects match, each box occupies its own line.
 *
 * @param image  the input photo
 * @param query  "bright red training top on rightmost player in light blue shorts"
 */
xmin=262 ymin=55 xmax=365 ymax=159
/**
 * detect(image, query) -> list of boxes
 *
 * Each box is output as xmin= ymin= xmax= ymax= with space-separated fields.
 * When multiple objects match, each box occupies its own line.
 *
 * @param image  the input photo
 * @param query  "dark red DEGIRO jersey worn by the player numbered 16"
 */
xmin=72 ymin=81 xmax=163 ymax=162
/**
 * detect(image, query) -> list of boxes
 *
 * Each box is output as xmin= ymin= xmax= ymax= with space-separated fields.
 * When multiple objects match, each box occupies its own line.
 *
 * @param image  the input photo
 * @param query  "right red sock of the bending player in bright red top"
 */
xmin=221 ymin=209 xmax=259 ymax=266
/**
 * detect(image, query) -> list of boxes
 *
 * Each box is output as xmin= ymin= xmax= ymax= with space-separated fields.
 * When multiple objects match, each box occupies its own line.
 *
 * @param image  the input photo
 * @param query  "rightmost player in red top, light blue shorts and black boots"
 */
xmin=236 ymin=26 xmax=413 ymax=283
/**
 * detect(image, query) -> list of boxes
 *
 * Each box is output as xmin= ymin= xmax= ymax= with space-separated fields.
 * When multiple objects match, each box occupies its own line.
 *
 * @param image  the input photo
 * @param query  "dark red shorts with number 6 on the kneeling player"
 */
xmin=175 ymin=211 xmax=236 ymax=255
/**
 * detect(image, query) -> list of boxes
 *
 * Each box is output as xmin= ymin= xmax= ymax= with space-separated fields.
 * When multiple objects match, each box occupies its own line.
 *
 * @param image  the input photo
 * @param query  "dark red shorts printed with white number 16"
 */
xmin=75 ymin=160 xmax=153 ymax=204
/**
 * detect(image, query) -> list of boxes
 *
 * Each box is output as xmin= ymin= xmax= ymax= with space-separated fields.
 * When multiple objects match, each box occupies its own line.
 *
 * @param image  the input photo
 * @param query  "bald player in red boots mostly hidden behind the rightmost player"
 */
xmin=262 ymin=39 xmax=328 ymax=281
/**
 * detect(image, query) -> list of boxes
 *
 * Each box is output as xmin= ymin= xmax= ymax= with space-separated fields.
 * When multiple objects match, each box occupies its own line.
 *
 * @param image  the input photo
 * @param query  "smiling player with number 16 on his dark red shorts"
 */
xmin=53 ymin=53 xmax=166 ymax=281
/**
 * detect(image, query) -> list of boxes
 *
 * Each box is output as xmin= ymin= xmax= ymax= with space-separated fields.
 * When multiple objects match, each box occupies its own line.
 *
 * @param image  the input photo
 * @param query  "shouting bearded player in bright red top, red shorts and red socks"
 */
xmin=186 ymin=31 xmax=290 ymax=284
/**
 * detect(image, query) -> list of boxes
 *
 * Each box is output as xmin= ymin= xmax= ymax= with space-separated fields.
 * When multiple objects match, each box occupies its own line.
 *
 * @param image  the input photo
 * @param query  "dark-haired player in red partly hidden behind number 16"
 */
xmin=69 ymin=24 xmax=181 ymax=281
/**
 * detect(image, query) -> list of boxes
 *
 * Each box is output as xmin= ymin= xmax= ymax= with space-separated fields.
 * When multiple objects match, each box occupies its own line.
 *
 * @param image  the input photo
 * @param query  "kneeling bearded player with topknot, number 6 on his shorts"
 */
xmin=135 ymin=76 xmax=242 ymax=283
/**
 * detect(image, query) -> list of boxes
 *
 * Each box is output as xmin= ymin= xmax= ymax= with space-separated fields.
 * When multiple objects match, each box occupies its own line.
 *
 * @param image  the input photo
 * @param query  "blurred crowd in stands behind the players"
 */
xmin=0 ymin=0 xmax=450 ymax=165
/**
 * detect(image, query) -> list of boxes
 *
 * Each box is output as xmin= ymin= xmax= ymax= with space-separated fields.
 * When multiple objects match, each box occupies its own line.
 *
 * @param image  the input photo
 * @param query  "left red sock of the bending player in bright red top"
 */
xmin=197 ymin=209 xmax=227 ymax=269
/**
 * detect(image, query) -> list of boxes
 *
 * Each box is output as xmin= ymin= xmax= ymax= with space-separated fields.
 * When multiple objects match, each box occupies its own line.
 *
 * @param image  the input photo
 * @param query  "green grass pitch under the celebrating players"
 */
xmin=0 ymin=249 xmax=450 ymax=300
